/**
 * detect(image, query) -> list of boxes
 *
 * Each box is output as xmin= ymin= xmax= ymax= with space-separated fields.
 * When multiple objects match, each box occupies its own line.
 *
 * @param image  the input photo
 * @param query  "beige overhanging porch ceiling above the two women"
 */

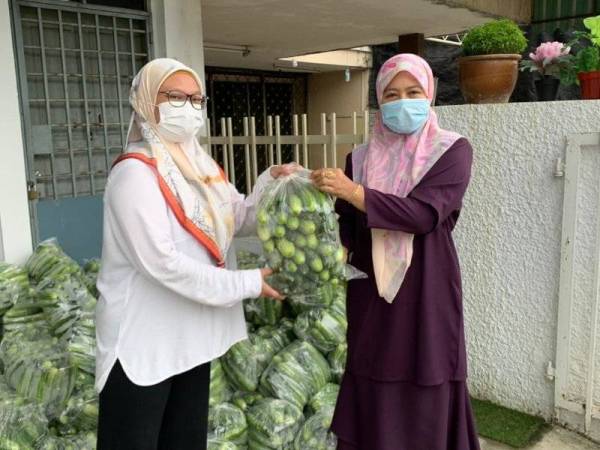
xmin=202 ymin=0 xmax=496 ymax=70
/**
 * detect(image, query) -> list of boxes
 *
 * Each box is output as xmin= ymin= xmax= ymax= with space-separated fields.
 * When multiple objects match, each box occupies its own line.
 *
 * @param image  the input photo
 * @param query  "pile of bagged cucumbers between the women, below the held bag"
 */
xmin=209 ymin=251 xmax=347 ymax=450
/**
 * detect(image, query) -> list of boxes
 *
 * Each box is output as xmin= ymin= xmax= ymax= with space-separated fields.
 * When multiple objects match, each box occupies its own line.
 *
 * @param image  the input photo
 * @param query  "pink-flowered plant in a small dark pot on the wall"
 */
xmin=521 ymin=41 xmax=571 ymax=101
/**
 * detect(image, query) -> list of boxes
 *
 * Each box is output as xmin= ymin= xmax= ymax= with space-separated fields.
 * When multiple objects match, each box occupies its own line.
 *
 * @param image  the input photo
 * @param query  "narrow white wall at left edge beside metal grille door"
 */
xmin=0 ymin=2 xmax=32 ymax=263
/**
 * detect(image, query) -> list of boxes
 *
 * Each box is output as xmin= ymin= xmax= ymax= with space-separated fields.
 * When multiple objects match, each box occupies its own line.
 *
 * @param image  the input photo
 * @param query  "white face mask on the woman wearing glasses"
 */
xmin=158 ymin=101 xmax=204 ymax=142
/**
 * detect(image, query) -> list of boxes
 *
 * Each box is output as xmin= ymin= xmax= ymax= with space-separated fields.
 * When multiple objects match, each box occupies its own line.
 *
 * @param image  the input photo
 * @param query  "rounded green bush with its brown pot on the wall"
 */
xmin=458 ymin=19 xmax=527 ymax=103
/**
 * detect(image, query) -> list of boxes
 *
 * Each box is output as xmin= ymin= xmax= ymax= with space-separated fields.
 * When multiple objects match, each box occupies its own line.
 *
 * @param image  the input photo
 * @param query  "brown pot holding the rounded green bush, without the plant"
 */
xmin=458 ymin=55 xmax=521 ymax=103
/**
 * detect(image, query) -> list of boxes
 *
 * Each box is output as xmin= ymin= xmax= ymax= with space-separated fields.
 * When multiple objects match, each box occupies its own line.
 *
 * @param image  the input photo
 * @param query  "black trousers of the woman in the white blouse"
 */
xmin=97 ymin=361 xmax=210 ymax=450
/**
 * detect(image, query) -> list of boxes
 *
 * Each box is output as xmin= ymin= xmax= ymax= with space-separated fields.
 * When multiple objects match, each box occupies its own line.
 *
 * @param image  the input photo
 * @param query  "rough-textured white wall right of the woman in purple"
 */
xmin=437 ymin=101 xmax=600 ymax=419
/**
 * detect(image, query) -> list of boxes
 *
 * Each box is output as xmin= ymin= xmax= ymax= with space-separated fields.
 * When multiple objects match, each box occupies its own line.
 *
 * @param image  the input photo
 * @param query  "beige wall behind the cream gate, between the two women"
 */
xmin=307 ymin=70 xmax=369 ymax=168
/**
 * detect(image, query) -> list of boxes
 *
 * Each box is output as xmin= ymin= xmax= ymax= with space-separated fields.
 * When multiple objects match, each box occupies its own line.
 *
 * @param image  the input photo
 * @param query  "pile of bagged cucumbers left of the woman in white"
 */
xmin=0 ymin=240 xmax=98 ymax=450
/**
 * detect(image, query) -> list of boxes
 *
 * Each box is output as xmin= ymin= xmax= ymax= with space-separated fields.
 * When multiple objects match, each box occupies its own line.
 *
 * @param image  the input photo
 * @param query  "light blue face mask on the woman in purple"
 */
xmin=381 ymin=98 xmax=430 ymax=134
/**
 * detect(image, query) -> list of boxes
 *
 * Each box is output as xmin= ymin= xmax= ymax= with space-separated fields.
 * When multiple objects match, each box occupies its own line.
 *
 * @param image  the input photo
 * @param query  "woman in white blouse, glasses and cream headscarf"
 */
xmin=96 ymin=59 xmax=297 ymax=450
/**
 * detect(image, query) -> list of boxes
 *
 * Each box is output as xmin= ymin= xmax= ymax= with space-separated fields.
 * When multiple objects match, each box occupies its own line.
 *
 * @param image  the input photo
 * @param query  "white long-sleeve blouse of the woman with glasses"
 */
xmin=96 ymin=153 xmax=272 ymax=391
